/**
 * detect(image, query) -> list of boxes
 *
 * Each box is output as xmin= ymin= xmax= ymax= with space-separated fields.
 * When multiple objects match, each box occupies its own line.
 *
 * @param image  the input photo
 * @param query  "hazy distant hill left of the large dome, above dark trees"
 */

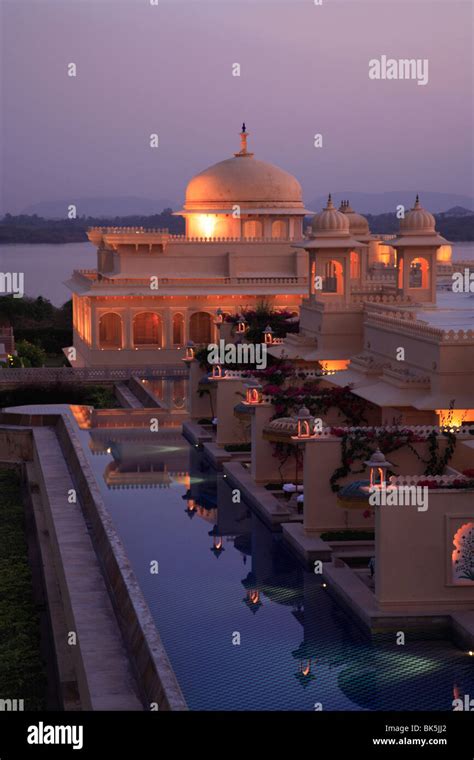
xmin=22 ymin=196 xmax=180 ymax=219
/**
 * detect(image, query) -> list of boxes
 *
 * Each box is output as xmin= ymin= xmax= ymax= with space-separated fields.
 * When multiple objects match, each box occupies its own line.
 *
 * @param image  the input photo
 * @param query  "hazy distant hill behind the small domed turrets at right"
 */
xmin=307 ymin=190 xmax=474 ymax=216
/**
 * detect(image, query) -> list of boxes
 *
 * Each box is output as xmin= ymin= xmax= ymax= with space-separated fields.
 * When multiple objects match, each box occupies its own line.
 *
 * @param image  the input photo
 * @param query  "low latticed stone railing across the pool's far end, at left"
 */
xmin=0 ymin=365 xmax=188 ymax=385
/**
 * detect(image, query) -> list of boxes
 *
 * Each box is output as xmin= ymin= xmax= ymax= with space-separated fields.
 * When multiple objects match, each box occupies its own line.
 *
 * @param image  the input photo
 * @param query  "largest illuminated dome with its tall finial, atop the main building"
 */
xmin=184 ymin=124 xmax=305 ymax=214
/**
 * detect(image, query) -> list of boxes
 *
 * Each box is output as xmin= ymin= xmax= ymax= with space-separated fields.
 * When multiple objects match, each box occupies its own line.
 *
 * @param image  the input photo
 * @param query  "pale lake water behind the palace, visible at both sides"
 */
xmin=0 ymin=242 xmax=474 ymax=306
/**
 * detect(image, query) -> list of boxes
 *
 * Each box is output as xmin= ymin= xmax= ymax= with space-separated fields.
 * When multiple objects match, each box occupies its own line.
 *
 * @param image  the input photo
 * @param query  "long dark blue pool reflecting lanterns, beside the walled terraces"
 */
xmin=75 ymin=428 xmax=474 ymax=711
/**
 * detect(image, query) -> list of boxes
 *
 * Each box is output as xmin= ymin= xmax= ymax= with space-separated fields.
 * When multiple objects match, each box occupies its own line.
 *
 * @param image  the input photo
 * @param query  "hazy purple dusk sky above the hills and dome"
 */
xmin=0 ymin=0 xmax=474 ymax=213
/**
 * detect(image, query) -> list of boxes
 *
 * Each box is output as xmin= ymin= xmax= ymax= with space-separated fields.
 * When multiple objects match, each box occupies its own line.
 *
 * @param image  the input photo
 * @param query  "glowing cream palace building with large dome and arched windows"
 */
xmin=65 ymin=125 xmax=310 ymax=367
